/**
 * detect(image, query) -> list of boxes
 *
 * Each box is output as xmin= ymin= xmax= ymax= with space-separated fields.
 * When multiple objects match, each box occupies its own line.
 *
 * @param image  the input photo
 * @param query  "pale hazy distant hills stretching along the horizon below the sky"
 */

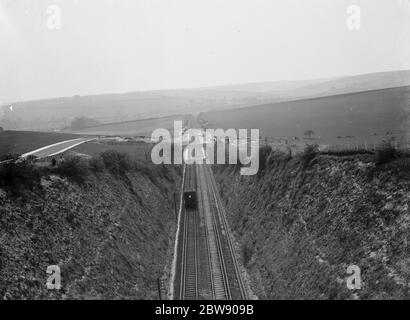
xmin=0 ymin=70 xmax=410 ymax=131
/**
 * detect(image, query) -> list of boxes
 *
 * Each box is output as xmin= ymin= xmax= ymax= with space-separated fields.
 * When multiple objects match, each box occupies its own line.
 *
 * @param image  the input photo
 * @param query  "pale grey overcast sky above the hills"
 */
xmin=0 ymin=0 xmax=410 ymax=102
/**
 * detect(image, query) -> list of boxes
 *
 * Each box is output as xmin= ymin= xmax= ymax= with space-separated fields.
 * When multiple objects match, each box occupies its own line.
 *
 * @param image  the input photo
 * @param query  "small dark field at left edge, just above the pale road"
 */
xmin=0 ymin=131 xmax=81 ymax=157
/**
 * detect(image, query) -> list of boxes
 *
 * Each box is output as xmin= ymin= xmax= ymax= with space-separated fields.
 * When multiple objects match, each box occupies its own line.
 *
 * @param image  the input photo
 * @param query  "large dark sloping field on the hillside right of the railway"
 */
xmin=200 ymin=87 xmax=410 ymax=144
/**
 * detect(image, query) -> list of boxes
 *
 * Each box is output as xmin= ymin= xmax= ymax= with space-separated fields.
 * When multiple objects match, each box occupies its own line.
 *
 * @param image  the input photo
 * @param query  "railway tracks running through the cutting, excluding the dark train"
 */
xmin=174 ymin=165 xmax=247 ymax=300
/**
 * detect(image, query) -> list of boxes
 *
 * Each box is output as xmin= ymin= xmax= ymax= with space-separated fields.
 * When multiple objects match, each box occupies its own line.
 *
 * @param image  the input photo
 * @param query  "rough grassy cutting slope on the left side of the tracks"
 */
xmin=0 ymin=168 xmax=178 ymax=299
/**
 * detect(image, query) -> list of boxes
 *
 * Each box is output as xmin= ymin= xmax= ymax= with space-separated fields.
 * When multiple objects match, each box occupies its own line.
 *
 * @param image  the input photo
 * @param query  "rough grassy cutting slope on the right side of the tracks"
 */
xmin=216 ymin=155 xmax=410 ymax=299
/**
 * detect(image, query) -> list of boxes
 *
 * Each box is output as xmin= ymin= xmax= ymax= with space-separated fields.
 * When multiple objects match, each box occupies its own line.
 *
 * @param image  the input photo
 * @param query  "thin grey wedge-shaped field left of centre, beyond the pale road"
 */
xmin=71 ymin=115 xmax=185 ymax=137
